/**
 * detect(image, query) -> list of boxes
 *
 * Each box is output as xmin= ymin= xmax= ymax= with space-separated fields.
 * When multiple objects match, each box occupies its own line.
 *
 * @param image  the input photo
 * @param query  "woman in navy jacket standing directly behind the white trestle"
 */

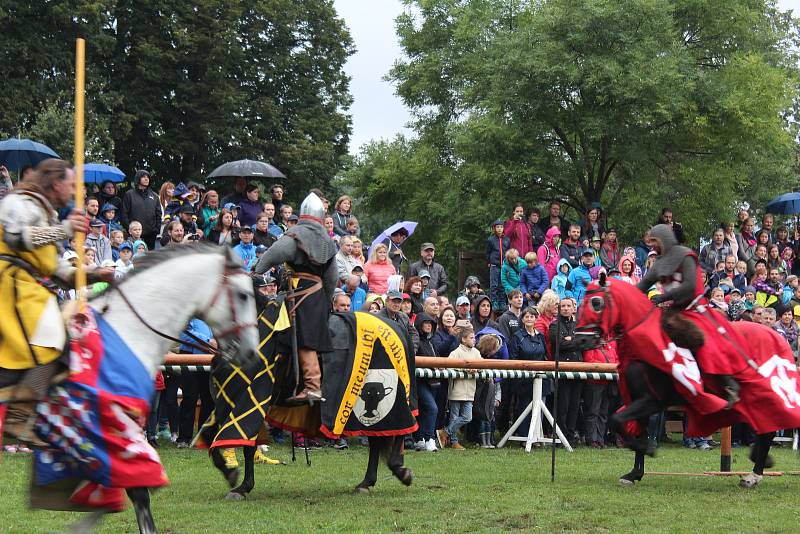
xmin=509 ymin=307 xmax=551 ymax=436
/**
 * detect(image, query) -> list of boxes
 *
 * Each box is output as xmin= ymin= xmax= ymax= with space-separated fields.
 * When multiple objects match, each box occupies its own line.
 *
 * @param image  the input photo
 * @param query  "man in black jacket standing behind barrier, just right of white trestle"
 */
xmin=549 ymin=298 xmax=583 ymax=441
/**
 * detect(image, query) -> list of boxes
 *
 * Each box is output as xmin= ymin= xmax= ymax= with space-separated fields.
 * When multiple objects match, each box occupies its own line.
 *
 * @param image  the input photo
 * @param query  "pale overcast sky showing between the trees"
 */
xmin=334 ymin=0 xmax=800 ymax=154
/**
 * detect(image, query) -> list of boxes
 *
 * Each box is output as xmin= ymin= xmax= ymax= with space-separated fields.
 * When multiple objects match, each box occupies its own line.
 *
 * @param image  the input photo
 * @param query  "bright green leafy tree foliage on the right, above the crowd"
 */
xmin=349 ymin=0 xmax=798 ymax=249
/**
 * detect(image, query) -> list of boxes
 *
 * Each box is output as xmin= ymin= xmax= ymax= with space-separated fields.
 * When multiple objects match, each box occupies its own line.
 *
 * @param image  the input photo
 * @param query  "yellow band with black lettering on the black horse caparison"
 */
xmin=333 ymin=312 xmax=411 ymax=434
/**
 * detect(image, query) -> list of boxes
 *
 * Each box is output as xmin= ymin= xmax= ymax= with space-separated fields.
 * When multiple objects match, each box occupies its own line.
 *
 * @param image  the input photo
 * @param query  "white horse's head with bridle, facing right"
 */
xmin=197 ymin=247 xmax=259 ymax=365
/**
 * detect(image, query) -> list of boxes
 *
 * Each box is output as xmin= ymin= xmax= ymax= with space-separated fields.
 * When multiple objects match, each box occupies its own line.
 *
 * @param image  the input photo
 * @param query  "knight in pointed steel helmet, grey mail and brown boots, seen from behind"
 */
xmin=255 ymin=193 xmax=337 ymax=404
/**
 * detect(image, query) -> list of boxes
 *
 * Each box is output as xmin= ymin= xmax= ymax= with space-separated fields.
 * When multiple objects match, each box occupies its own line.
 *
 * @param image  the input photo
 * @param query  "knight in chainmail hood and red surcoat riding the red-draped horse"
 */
xmin=637 ymin=224 xmax=749 ymax=407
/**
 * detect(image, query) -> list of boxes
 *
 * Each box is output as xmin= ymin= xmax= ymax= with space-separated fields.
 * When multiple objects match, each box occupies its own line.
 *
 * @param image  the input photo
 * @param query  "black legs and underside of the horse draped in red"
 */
xmin=609 ymin=361 xmax=775 ymax=487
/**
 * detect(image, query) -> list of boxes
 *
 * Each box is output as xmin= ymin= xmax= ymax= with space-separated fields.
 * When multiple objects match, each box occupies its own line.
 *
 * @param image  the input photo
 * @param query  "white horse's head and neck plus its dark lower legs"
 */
xmin=25 ymin=243 xmax=259 ymax=534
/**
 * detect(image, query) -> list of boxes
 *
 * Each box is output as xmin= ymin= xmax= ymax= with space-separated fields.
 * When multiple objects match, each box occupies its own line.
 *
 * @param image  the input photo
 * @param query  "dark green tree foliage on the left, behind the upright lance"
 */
xmin=0 ymin=0 xmax=353 ymax=190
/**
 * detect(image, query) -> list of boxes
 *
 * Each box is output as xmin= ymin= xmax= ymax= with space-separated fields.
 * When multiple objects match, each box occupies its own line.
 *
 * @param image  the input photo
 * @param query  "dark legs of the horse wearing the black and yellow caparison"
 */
xmin=211 ymin=436 xmax=414 ymax=501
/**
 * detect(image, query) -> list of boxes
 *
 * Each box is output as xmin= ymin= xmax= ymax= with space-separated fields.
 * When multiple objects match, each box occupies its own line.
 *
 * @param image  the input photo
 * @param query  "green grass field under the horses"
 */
xmin=0 ymin=440 xmax=800 ymax=534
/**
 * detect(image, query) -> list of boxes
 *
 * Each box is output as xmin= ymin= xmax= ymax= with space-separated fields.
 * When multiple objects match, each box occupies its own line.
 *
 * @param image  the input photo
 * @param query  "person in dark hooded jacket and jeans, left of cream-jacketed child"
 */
xmin=414 ymin=313 xmax=441 ymax=452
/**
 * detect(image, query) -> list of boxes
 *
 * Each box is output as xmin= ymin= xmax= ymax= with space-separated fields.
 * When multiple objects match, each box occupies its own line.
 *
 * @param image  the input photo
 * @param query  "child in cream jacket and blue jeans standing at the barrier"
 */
xmin=439 ymin=327 xmax=481 ymax=450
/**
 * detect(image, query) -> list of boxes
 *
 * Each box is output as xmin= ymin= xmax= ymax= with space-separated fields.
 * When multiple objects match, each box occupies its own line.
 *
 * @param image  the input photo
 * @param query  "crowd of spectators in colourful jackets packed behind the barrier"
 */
xmin=3 ymin=164 xmax=800 ymax=451
